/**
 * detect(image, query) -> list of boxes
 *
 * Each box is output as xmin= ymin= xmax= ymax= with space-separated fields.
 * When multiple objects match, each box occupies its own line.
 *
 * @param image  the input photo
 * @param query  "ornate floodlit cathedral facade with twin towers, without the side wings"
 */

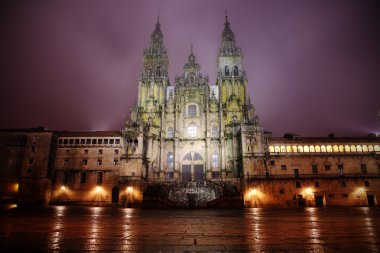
xmin=121 ymin=17 xmax=264 ymax=181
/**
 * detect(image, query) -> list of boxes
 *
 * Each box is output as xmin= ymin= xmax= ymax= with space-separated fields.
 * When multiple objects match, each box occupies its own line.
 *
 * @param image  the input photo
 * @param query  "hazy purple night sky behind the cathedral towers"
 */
xmin=0 ymin=0 xmax=380 ymax=136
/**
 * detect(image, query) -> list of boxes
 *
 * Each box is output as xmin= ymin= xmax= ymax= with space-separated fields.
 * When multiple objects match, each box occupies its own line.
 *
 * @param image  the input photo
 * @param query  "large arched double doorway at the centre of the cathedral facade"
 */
xmin=181 ymin=152 xmax=204 ymax=182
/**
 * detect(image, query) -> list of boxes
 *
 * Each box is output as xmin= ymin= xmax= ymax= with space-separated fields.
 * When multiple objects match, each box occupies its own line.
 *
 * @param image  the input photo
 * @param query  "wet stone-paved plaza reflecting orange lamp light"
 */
xmin=0 ymin=206 xmax=380 ymax=252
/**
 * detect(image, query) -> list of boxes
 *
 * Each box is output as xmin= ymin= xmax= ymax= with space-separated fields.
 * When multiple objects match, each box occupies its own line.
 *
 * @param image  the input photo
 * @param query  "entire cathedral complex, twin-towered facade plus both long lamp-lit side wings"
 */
xmin=0 ymin=17 xmax=380 ymax=208
